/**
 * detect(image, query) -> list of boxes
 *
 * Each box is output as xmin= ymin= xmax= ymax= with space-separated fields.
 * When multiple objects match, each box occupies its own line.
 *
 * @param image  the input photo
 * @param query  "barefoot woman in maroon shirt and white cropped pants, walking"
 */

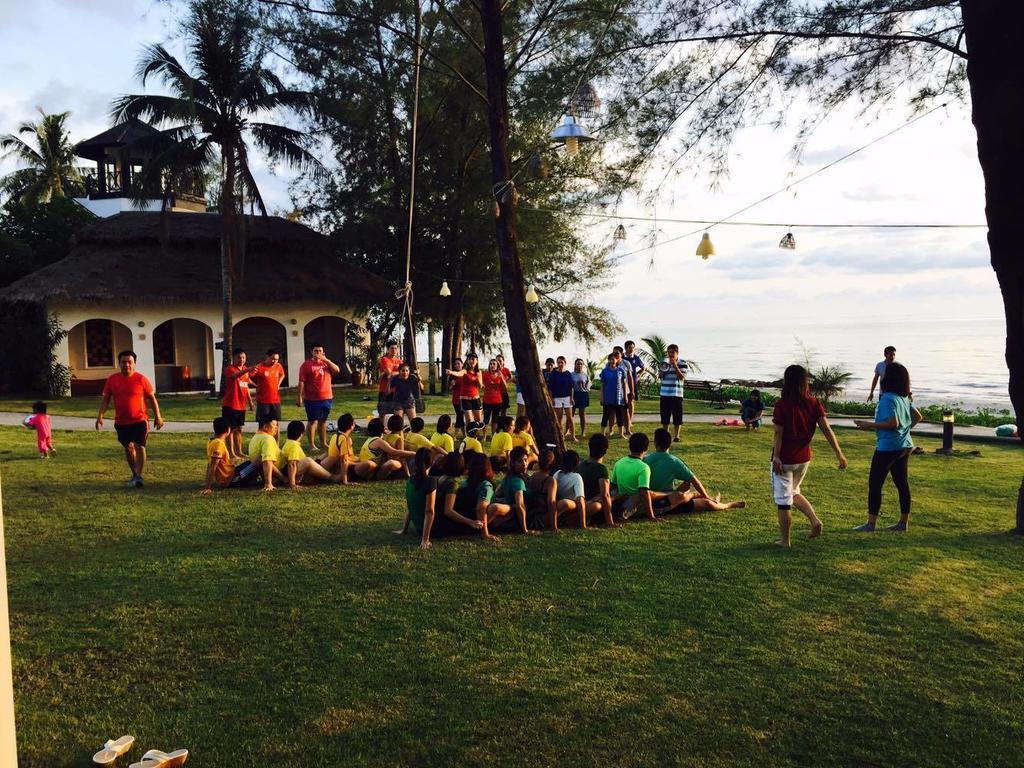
xmin=771 ymin=366 xmax=847 ymax=547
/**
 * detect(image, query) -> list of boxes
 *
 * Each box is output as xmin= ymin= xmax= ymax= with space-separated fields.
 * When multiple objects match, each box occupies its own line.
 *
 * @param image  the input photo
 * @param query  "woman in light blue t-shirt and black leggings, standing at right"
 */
xmin=854 ymin=362 xmax=921 ymax=532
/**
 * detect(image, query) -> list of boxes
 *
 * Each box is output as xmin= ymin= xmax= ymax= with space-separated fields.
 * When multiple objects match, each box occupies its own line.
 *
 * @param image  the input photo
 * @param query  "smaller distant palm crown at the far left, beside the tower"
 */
xmin=0 ymin=109 xmax=83 ymax=203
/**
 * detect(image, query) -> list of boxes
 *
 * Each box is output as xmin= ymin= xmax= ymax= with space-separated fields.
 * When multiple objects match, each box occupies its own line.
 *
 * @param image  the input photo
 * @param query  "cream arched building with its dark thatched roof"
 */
xmin=0 ymin=212 xmax=394 ymax=392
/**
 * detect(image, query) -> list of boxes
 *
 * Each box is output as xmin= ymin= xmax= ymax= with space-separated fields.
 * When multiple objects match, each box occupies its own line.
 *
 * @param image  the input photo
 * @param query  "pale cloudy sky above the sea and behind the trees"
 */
xmin=0 ymin=0 xmax=1002 ymax=403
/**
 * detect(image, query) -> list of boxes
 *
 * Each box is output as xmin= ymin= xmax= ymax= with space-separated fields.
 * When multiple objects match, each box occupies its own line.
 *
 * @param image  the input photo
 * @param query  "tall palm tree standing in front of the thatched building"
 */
xmin=112 ymin=0 xmax=324 ymax=367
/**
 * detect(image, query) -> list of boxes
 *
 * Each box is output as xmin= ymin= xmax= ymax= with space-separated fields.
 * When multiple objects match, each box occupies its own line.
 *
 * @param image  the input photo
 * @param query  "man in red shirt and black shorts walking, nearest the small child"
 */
xmin=96 ymin=349 xmax=164 ymax=488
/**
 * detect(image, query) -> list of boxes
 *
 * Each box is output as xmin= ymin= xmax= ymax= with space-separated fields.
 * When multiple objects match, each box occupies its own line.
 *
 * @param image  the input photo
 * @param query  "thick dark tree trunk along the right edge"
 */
xmin=961 ymin=0 xmax=1024 ymax=534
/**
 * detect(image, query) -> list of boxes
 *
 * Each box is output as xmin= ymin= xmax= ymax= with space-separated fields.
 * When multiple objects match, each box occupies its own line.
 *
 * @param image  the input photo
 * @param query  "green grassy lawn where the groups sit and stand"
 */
xmin=0 ymin=423 xmax=1024 ymax=768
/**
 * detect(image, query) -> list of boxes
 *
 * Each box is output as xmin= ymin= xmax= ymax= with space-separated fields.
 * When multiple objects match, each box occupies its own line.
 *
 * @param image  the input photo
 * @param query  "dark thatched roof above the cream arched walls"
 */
xmin=0 ymin=212 xmax=394 ymax=307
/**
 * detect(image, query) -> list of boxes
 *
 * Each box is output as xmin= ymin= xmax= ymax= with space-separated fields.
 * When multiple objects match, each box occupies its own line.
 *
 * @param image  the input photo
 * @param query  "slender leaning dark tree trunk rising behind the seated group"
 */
xmin=480 ymin=0 xmax=564 ymax=454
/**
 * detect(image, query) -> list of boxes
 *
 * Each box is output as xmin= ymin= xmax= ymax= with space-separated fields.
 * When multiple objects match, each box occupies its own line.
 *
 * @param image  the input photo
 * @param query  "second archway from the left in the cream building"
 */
xmin=153 ymin=317 xmax=215 ymax=392
